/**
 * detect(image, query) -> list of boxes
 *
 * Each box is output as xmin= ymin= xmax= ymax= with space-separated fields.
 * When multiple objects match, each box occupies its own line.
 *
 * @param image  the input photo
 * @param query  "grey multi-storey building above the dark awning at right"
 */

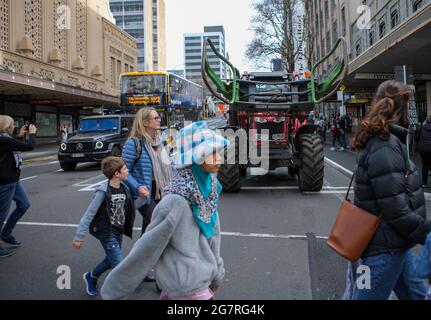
xmin=305 ymin=0 xmax=431 ymax=125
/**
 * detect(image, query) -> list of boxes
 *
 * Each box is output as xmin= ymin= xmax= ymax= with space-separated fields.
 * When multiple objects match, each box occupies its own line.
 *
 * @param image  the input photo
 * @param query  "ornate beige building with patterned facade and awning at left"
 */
xmin=0 ymin=0 xmax=137 ymax=142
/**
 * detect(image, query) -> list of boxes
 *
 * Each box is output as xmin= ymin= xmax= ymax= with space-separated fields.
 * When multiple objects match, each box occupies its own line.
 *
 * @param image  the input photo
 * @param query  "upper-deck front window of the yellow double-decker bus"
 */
xmin=121 ymin=74 xmax=166 ymax=95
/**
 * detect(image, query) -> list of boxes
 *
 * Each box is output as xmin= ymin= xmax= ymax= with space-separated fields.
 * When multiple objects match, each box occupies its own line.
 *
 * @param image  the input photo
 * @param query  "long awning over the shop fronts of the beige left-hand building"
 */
xmin=0 ymin=71 xmax=120 ymax=106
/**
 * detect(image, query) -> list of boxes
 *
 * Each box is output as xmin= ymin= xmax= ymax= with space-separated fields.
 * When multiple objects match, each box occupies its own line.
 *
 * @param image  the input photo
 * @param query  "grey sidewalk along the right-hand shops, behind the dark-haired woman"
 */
xmin=325 ymin=133 xmax=431 ymax=201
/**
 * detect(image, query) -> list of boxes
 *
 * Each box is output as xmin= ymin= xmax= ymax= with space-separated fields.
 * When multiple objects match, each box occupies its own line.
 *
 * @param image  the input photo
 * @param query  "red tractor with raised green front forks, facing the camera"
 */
xmin=201 ymin=38 xmax=348 ymax=192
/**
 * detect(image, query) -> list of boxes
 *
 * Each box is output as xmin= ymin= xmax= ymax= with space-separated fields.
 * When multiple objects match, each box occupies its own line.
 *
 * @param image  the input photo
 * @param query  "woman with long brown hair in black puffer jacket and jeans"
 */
xmin=352 ymin=81 xmax=431 ymax=300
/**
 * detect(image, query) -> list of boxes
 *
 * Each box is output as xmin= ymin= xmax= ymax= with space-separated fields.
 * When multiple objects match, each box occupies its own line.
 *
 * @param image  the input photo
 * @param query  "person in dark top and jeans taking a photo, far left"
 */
xmin=0 ymin=116 xmax=37 ymax=258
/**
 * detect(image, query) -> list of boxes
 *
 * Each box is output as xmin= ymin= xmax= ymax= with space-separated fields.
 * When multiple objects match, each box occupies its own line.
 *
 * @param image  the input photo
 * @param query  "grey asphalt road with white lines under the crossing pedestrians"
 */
xmin=0 ymin=154 xmax=429 ymax=300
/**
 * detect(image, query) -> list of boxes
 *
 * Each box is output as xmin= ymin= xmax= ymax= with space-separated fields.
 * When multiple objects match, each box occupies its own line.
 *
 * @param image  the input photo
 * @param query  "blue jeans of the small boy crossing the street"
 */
xmin=91 ymin=234 xmax=123 ymax=279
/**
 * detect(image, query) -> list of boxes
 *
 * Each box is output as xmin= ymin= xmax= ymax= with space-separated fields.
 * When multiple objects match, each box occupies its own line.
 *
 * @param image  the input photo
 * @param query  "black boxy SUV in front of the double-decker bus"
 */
xmin=58 ymin=115 xmax=134 ymax=171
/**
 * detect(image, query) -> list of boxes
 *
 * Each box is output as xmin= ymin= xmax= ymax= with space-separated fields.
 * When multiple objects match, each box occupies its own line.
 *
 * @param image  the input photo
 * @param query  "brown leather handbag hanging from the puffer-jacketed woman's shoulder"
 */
xmin=327 ymin=175 xmax=382 ymax=262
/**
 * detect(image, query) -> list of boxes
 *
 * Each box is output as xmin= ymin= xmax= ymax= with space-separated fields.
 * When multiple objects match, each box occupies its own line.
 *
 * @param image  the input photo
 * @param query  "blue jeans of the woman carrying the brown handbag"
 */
xmin=354 ymin=250 xmax=427 ymax=300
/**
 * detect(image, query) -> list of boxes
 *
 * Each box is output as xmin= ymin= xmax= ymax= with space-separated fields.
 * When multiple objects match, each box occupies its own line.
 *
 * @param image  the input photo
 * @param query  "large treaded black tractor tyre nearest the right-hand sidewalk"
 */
xmin=298 ymin=134 xmax=325 ymax=192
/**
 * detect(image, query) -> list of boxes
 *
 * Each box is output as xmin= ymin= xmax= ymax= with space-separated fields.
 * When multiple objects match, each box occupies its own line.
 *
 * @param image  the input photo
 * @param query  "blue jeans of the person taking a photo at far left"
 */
xmin=0 ymin=181 xmax=31 ymax=236
